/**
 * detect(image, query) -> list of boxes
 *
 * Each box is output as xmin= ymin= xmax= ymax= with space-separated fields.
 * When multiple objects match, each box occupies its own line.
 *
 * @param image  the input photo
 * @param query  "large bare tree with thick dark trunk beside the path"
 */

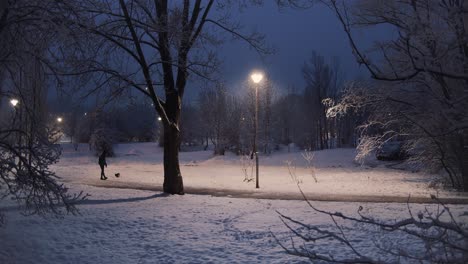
xmin=53 ymin=0 xmax=289 ymax=194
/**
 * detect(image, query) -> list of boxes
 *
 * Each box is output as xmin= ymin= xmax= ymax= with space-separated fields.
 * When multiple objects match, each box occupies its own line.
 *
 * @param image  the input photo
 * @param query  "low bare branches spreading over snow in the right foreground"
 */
xmin=275 ymin=193 xmax=468 ymax=263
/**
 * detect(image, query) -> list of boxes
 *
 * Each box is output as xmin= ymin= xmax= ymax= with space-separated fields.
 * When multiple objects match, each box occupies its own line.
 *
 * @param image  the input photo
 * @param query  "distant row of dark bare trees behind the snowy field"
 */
xmin=56 ymin=52 xmax=363 ymax=155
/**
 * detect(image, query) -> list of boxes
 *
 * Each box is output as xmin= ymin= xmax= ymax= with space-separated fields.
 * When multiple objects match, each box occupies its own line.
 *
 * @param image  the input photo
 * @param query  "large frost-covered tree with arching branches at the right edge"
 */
xmin=326 ymin=0 xmax=468 ymax=191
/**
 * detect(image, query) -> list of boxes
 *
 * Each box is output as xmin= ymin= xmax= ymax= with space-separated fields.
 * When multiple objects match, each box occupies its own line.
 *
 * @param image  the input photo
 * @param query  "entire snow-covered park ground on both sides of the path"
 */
xmin=0 ymin=143 xmax=468 ymax=263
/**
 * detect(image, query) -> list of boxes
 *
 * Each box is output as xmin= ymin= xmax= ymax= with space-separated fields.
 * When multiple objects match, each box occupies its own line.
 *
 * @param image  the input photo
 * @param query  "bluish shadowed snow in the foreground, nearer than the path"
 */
xmin=0 ymin=186 xmax=468 ymax=263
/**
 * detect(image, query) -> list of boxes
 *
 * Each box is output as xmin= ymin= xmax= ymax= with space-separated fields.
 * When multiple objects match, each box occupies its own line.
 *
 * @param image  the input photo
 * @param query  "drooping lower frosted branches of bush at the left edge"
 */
xmin=0 ymin=116 xmax=83 ymax=226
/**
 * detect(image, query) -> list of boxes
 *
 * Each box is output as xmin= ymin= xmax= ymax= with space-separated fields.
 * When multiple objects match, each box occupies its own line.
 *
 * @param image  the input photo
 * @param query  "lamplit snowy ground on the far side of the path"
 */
xmin=53 ymin=143 xmax=464 ymax=201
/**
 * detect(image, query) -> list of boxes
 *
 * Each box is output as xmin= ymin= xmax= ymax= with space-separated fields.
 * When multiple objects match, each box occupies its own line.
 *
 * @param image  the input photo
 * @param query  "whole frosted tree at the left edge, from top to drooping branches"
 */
xmin=0 ymin=0 xmax=81 ymax=225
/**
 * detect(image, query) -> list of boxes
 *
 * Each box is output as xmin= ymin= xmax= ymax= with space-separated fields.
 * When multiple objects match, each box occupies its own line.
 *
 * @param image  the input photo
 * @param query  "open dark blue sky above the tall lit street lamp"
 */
xmin=210 ymin=1 xmax=389 ymax=96
